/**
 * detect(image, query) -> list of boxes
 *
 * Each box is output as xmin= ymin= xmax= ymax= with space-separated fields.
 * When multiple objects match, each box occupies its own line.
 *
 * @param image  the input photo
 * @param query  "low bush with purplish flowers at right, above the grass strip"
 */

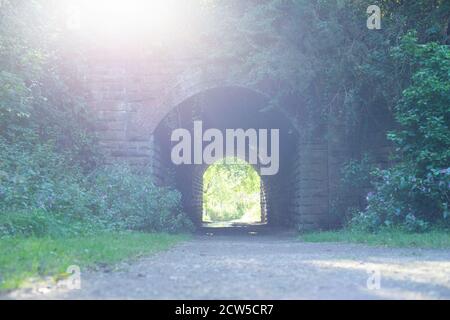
xmin=351 ymin=165 xmax=450 ymax=231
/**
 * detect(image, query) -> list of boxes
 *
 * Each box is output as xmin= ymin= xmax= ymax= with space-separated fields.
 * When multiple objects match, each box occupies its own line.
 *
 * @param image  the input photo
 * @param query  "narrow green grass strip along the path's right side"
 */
xmin=300 ymin=229 xmax=450 ymax=248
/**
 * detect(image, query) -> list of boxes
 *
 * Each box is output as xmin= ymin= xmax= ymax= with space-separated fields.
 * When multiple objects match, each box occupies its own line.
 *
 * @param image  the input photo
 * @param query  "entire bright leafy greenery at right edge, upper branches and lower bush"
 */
xmin=351 ymin=33 xmax=450 ymax=231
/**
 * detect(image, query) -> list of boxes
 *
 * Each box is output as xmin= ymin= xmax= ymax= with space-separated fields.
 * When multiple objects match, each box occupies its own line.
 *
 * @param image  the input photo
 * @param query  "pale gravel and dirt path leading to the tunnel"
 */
xmin=5 ymin=236 xmax=450 ymax=299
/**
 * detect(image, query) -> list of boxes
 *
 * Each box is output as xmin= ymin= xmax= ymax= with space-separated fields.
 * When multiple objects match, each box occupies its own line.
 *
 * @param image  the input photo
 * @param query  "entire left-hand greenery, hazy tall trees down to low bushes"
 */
xmin=0 ymin=0 xmax=190 ymax=236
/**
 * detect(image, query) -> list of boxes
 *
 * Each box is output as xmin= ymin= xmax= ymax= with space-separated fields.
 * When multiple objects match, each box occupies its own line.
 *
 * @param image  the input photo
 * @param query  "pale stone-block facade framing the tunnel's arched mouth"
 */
xmin=90 ymin=62 xmax=339 ymax=228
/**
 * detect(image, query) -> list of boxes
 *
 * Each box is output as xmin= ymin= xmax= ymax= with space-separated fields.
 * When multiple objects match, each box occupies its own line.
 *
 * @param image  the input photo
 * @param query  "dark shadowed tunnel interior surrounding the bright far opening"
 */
xmin=153 ymin=87 xmax=298 ymax=227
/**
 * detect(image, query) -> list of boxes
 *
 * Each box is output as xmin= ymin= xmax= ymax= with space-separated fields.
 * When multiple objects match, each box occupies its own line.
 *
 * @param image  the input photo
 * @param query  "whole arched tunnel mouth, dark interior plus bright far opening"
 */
xmin=152 ymin=87 xmax=306 ymax=229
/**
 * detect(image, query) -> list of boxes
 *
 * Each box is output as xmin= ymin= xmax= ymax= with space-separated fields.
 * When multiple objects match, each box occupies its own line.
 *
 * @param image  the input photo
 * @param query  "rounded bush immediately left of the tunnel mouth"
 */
xmin=89 ymin=165 xmax=192 ymax=232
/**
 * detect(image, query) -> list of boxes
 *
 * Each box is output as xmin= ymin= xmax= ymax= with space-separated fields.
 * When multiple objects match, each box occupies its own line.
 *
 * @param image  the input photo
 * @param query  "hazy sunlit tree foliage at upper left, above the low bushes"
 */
xmin=0 ymin=0 xmax=99 ymax=169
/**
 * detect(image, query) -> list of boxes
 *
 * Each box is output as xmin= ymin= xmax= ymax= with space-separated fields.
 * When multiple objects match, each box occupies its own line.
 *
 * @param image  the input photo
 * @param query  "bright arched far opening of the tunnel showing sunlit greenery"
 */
xmin=202 ymin=158 xmax=266 ymax=228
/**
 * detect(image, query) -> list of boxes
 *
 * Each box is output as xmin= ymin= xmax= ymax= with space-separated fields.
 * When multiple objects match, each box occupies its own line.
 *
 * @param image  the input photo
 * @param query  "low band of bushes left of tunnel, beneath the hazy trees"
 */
xmin=0 ymin=140 xmax=192 ymax=236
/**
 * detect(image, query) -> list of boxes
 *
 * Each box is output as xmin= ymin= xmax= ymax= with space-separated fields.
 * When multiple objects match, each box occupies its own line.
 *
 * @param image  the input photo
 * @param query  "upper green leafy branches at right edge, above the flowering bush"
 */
xmin=389 ymin=34 xmax=450 ymax=173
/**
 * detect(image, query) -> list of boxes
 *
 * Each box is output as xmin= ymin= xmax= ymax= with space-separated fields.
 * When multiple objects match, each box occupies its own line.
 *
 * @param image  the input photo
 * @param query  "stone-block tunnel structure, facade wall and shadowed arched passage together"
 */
xmin=85 ymin=51 xmax=340 ymax=230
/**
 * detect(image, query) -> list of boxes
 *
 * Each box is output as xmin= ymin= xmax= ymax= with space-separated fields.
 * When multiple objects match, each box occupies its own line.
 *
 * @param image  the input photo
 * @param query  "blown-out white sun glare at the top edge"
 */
xmin=68 ymin=0 xmax=201 ymax=40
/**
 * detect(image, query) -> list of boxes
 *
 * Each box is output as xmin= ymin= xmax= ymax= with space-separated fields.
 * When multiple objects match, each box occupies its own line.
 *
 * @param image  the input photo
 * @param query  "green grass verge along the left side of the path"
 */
xmin=0 ymin=232 xmax=188 ymax=291
